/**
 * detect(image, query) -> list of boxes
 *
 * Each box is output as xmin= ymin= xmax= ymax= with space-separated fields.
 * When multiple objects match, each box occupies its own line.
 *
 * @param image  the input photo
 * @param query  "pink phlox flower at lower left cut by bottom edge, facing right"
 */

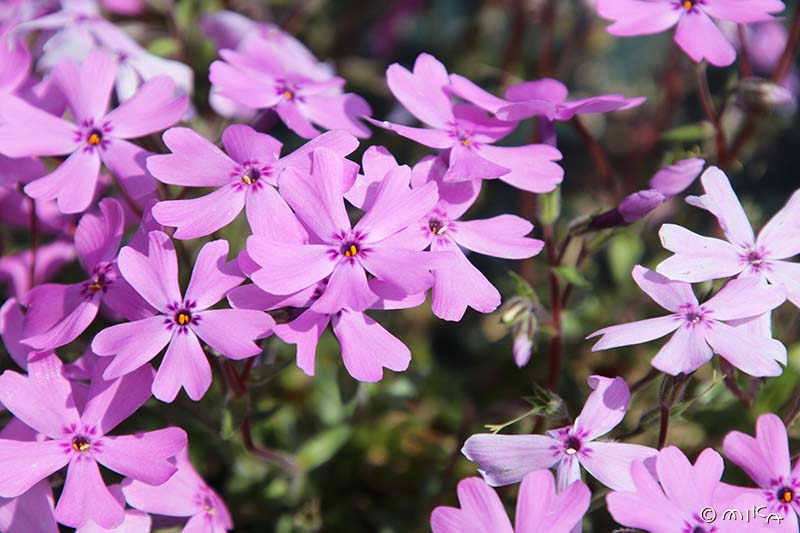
xmin=122 ymin=449 xmax=233 ymax=533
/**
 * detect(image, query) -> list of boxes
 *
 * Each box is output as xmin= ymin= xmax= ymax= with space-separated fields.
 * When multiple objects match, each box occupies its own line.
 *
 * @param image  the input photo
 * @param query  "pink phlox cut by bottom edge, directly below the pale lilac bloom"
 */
xmin=431 ymin=471 xmax=592 ymax=533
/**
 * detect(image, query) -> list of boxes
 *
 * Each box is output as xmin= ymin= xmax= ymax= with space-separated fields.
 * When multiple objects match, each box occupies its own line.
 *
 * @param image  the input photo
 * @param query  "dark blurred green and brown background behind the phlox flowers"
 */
xmin=2 ymin=0 xmax=800 ymax=533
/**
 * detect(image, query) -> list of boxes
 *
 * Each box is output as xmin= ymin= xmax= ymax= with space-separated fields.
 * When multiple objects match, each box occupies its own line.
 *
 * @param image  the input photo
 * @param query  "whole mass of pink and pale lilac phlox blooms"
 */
xmin=0 ymin=0 xmax=800 ymax=533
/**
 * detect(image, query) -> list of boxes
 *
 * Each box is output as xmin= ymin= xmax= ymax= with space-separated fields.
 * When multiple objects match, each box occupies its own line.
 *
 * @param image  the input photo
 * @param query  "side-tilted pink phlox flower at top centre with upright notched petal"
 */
xmin=369 ymin=54 xmax=564 ymax=193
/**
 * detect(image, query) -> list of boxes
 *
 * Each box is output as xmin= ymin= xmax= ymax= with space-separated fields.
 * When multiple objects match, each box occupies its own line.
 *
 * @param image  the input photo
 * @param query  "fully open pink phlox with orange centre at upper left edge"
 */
xmin=0 ymin=52 xmax=187 ymax=213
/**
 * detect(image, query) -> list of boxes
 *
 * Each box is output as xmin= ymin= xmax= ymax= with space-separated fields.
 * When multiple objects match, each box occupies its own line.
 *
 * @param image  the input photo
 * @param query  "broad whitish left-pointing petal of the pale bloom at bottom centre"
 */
xmin=461 ymin=433 xmax=559 ymax=487
